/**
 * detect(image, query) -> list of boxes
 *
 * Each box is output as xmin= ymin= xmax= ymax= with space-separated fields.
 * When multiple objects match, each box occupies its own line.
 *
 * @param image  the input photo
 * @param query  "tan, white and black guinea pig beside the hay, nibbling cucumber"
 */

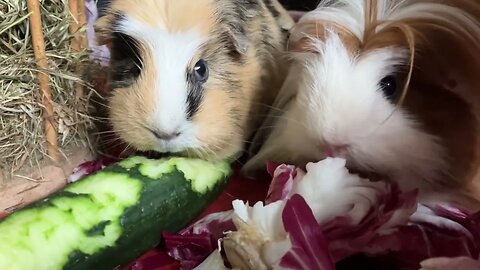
xmin=95 ymin=0 xmax=294 ymax=160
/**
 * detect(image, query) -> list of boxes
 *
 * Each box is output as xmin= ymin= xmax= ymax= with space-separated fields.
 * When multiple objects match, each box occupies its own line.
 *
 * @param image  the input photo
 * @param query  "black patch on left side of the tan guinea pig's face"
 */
xmin=110 ymin=14 xmax=143 ymax=88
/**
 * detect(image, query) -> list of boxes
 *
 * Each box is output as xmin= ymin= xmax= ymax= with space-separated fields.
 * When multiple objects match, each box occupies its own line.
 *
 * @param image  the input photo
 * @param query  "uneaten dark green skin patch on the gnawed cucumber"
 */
xmin=64 ymin=167 xmax=227 ymax=270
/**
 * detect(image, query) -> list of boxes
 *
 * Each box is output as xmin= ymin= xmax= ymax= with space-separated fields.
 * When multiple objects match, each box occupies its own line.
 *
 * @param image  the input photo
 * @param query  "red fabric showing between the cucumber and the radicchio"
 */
xmin=124 ymin=166 xmax=270 ymax=270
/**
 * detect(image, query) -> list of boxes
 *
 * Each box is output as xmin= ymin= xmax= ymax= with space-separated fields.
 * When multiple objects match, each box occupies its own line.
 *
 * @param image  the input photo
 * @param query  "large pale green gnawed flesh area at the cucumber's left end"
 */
xmin=0 ymin=172 xmax=142 ymax=270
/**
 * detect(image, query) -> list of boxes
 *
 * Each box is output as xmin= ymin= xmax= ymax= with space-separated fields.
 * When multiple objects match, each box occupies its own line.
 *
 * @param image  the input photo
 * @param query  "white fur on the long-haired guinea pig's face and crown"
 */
xmin=244 ymin=0 xmax=480 ymax=191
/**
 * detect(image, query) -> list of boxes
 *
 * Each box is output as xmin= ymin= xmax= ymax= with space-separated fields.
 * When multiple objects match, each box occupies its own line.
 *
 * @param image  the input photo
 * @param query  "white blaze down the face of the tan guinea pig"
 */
xmin=119 ymin=18 xmax=205 ymax=152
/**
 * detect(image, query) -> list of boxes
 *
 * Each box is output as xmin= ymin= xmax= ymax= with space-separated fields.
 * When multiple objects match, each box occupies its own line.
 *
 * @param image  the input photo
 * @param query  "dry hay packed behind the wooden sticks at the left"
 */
xmin=0 ymin=0 xmax=97 ymax=178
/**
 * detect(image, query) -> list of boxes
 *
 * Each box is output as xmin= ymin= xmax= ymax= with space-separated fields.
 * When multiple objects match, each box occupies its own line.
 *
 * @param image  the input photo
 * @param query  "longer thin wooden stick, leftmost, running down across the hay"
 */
xmin=27 ymin=0 xmax=58 ymax=161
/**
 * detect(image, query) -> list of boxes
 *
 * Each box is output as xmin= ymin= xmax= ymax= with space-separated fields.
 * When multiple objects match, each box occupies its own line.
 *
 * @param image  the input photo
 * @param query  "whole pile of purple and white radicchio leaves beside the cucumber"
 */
xmin=135 ymin=158 xmax=480 ymax=270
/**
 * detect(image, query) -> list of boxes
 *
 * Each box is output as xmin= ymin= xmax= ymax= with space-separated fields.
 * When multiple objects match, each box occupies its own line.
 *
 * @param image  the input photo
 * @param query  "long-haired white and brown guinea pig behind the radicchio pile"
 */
xmin=243 ymin=0 xmax=480 ymax=207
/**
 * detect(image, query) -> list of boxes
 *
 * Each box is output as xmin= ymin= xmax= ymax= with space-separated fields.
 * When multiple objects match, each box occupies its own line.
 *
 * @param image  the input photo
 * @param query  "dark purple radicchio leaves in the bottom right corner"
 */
xmin=362 ymin=202 xmax=480 ymax=269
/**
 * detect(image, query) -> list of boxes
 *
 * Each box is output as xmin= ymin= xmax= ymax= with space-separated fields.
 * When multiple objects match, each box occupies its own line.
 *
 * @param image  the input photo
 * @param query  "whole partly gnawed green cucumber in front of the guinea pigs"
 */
xmin=0 ymin=156 xmax=231 ymax=270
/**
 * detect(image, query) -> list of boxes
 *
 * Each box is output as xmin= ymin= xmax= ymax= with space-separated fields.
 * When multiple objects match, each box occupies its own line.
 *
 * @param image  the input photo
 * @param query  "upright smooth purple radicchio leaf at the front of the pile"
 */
xmin=280 ymin=194 xmax=335 ymax=270
